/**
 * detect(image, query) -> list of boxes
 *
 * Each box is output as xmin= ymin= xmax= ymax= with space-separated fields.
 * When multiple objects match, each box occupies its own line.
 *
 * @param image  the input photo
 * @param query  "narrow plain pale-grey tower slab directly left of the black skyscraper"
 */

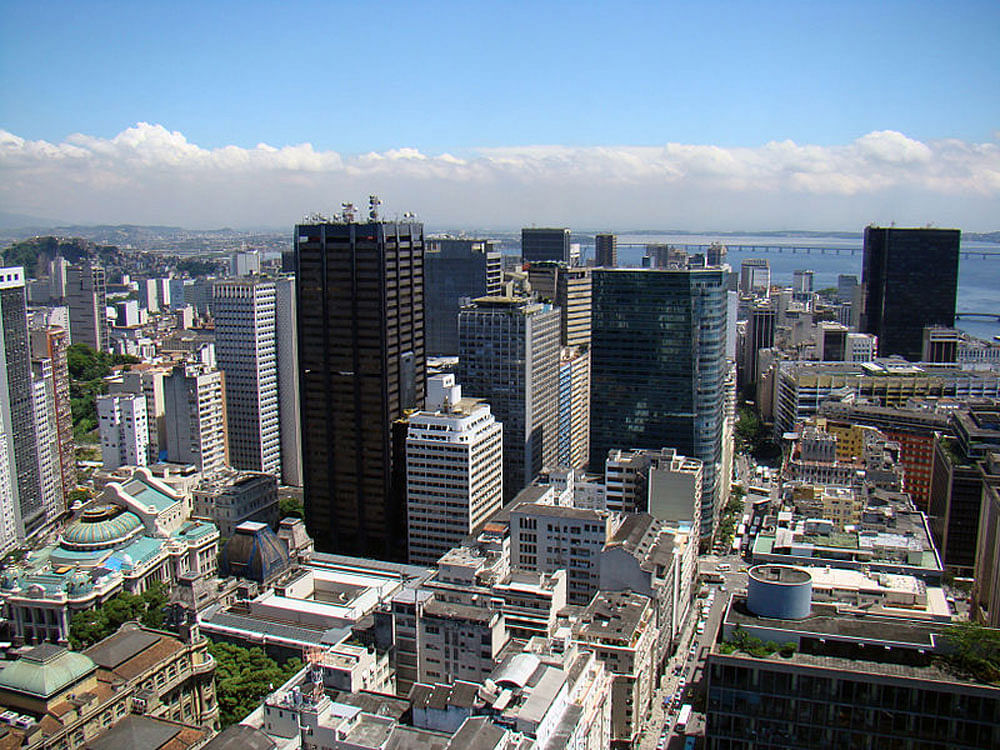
xmin=274 ymin=276 xmax=302 ymax=487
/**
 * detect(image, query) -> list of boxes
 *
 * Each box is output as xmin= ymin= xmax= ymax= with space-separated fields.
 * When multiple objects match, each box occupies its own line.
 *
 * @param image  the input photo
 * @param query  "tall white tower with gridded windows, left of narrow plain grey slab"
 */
xmin=213 ymin=276 xmax=281 ymax=475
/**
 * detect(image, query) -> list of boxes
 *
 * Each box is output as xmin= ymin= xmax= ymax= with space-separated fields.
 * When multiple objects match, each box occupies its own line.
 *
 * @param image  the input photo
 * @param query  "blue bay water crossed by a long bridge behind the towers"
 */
xmin=589 ymin=235 xmax=1000 ymax=339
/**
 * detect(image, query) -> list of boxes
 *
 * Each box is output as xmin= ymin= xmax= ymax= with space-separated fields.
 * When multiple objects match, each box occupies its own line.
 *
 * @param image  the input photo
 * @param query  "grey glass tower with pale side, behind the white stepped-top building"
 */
xmin=458 ymin=297 xmax=560 ymax=502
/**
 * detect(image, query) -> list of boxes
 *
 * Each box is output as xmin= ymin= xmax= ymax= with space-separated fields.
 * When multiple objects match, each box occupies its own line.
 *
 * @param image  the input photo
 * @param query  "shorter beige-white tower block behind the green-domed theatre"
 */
xmin=163 ymin=363 xmax=229 ymax=476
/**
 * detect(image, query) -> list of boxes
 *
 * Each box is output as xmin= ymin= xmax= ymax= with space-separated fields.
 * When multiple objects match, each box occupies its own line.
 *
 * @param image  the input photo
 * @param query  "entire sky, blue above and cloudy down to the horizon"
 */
xmin=0 ymin=0 xmax=1000 ymax=231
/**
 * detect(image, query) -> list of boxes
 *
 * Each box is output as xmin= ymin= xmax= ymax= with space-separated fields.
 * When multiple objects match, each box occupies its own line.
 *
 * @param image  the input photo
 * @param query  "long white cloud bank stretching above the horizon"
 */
xmin=0 ymin=122 xmax=1000 ymax=230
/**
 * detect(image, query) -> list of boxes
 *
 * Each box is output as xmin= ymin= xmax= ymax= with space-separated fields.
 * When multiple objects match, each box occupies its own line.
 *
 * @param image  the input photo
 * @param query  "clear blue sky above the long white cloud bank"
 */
xmin=0 ymin=0 xmax=1000 ymax=229
